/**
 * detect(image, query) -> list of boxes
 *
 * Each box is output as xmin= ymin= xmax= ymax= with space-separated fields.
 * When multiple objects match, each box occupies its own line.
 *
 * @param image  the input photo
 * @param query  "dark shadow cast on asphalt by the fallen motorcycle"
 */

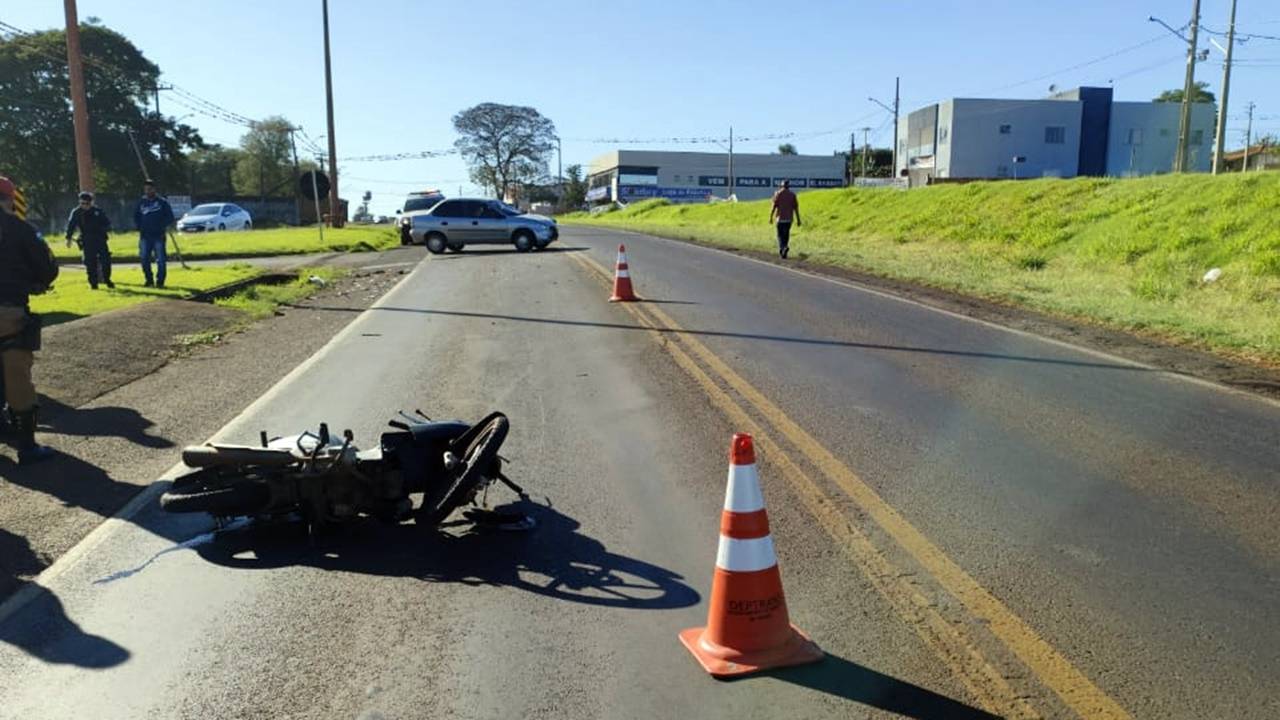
xmin=197 ymin=502 xmax=700 ymax=610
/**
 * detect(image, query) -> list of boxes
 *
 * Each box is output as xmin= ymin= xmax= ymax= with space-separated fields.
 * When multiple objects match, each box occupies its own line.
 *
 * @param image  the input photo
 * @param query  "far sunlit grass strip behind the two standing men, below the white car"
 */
xmin=49 ymin=225 xmax=399 ymax=264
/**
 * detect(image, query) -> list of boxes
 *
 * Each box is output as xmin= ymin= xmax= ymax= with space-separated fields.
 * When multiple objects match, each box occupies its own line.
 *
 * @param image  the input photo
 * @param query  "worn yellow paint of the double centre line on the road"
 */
xmin=572 ymin=248 xmax=1130 ymax=719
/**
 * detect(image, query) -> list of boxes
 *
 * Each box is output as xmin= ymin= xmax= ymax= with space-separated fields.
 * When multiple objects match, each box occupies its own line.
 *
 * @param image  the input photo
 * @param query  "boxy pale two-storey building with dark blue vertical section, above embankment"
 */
xmin=895 ymin=87 xmax=1217 ymax=184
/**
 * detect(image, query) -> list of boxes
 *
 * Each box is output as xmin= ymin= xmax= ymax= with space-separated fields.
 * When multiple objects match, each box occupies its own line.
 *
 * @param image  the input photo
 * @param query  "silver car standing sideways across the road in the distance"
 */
xmin=410 ymin=197 xmax=559 ymax=254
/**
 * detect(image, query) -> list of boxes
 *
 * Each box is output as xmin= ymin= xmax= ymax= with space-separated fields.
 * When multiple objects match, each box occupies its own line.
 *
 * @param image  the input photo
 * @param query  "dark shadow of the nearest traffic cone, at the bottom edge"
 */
xmin=767 ymin=653 xmax=998 ymax=720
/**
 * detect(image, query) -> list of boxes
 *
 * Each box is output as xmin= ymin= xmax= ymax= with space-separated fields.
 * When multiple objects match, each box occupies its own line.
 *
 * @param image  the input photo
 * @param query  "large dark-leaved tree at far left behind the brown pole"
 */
xmin=0 ymin=23 xmax=202 ymax=217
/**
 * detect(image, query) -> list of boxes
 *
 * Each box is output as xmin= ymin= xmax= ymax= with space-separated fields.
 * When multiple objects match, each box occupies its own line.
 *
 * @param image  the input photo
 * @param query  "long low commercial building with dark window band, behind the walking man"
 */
xmin=586 ymin=150 xmax=845 ymax=202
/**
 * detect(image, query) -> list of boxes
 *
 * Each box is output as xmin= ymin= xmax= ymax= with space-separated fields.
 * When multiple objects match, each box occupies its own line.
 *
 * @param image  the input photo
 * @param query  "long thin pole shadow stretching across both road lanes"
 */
xmin=348 ymin=300 xmax=1151 ymax=373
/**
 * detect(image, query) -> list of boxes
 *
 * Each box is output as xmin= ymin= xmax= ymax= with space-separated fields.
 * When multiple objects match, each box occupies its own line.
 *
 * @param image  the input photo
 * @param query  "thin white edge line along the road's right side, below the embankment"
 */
xmin=577 ymin=225 xmax=1280 ymax=409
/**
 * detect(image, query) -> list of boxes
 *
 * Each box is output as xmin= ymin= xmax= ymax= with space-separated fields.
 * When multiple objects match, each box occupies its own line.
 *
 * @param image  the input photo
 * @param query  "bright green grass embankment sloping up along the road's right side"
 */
xmin=564 ymin=173 xmax=1280 ymax=365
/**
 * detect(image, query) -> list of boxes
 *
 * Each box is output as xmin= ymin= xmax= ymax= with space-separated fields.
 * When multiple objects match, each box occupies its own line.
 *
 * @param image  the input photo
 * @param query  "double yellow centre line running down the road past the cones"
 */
xmin=570 ymin=252 xmax=1130 ymax=720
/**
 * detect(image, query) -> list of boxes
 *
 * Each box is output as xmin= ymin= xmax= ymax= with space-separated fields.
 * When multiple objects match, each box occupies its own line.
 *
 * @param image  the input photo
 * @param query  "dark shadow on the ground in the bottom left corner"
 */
xmin=0 ymin=529 xmax=129 ymax=669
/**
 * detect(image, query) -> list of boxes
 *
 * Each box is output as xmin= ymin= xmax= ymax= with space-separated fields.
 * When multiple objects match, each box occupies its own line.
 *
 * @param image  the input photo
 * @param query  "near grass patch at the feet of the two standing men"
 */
xmin=31 ymin=264 xmax=260 ymax=325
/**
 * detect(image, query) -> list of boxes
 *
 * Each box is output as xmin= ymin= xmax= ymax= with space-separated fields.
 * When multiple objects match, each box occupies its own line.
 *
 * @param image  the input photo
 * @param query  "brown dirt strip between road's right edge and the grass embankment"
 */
xmin=668 ymin=237 xmax=1280 ymax=400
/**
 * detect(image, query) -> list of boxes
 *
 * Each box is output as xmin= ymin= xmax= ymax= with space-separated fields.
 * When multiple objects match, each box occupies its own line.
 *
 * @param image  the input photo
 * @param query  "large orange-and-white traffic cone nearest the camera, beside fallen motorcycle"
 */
xmin=680 ymin=433 xmax=823 ymax=678
